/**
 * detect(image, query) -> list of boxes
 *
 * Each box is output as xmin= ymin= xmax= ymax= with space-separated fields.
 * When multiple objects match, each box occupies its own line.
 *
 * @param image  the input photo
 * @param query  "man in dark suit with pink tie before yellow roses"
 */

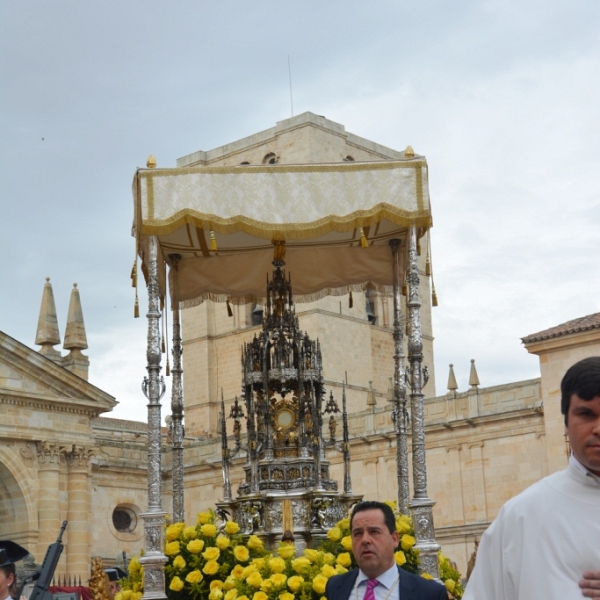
xmin=325 ymin=501 xmax=448 ymax=600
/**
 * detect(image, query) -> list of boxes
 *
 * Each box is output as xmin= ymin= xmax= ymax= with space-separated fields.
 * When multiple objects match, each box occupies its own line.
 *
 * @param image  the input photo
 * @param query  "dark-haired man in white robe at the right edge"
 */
xmin=463 ymin=356 xmax=600 ymax=600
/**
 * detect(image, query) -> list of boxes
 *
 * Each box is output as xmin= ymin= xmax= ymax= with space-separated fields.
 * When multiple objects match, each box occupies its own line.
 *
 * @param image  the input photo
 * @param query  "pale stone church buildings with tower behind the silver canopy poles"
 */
xmin=0 ymin=113 xmax=600 ymax=579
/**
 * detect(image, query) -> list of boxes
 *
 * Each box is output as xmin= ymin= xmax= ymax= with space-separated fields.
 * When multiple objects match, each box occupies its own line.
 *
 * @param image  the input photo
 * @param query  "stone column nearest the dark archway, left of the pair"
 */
xmin=36 ymin=442 xmax=66 ymax=561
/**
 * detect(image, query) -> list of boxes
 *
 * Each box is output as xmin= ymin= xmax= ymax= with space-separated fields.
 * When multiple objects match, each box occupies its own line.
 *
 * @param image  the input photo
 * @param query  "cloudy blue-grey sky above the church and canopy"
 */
xmin=0 ymin=0 xmax=600 ymax=418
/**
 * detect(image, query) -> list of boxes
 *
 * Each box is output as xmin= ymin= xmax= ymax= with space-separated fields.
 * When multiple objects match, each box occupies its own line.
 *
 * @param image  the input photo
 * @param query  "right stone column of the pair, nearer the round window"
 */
xmin=65 ymin=445 xmax=93 ymax=581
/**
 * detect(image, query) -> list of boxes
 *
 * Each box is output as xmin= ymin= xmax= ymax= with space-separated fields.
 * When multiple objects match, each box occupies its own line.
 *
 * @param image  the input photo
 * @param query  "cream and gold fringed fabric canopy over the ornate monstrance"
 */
xmin=133 ymin=157 xmax=432 ymax=306
